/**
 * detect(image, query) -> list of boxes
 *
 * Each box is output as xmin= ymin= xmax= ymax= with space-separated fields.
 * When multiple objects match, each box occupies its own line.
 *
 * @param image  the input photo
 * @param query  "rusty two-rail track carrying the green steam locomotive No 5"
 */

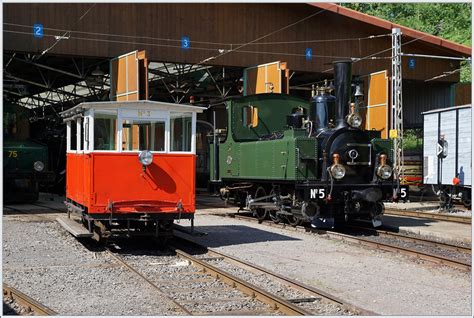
xmin=214 ymin=213 xmax=471 ymax=271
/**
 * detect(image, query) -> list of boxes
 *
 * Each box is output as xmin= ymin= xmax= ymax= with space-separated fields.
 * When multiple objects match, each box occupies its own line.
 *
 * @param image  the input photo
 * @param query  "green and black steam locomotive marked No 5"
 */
xmin=210 ymin=62 xmax=408 ymax=227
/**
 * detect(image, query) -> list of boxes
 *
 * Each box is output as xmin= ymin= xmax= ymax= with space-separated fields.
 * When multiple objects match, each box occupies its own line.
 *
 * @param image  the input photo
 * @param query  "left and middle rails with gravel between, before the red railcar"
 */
xmin=108 ymin=245 xmax=311 ymax=316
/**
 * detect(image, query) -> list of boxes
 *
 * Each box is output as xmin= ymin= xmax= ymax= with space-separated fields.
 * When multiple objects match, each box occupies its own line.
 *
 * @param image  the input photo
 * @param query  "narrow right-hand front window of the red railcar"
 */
xmin=171 ymin=113 xmax=192 ymax=151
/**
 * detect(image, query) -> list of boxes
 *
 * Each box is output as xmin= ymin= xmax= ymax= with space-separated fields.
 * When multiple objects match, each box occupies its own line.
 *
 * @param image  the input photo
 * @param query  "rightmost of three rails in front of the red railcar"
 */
xmin=174 ymin=237 xmax=378 ymax=316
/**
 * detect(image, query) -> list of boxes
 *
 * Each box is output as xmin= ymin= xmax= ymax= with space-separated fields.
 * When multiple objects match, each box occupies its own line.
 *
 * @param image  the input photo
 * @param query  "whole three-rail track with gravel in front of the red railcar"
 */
xmin=103 ymin=241 xmax=375 ymax=316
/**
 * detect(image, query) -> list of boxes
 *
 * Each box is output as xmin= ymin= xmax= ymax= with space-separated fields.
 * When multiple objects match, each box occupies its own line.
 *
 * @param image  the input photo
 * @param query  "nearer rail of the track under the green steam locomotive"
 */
xmin=221 ymin=214 xmax=471 ymax=271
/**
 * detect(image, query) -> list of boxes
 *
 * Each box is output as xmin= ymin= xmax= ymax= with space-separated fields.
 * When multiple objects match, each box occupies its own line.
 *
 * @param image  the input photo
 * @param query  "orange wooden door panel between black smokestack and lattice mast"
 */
xmin=365 ymin=70 xmax=389 ymax=138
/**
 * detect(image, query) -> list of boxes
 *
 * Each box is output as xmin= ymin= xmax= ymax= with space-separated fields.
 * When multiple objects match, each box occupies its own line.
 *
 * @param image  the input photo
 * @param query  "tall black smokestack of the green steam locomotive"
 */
xmin=334 ymin=61 xmax=352 ymax=128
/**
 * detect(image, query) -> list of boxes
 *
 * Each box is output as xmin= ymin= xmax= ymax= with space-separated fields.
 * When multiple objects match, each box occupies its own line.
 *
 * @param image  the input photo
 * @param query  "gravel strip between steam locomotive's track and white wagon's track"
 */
xmin=383 ymin=215 xmax=472 ymax=244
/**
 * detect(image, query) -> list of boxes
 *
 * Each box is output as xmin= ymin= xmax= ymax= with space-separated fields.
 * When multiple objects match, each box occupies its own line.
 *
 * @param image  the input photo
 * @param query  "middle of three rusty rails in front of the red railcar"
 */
xmin=172 ymin=249 xmax=313 ymax=316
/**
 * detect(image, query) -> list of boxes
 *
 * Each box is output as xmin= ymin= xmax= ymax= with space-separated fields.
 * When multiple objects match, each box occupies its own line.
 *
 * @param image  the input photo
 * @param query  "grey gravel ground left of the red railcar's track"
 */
xmin=3 ymin=217 xmax=183 ymax=316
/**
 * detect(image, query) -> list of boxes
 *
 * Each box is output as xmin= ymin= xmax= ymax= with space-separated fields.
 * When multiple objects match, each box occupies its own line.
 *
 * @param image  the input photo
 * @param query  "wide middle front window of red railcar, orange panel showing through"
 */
xmin=122 ymin=119 xmax=165 ymax=151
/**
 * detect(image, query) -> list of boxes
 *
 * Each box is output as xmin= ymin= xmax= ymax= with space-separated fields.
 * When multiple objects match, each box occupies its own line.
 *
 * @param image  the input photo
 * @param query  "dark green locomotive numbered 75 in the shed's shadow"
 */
xmin=3 ymin=103 xmax=54 ymax=203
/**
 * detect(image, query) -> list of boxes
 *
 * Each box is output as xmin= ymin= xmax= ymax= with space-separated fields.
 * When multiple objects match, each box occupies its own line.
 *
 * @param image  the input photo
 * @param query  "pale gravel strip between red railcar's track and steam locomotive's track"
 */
xmin=180 ymin=210 xmax=471 ymax=315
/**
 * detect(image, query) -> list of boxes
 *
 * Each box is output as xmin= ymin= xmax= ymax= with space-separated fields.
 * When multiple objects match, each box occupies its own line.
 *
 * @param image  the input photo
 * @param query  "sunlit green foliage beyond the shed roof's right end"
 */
xmin=343 ymin=3 xmax=472 ymax=82
